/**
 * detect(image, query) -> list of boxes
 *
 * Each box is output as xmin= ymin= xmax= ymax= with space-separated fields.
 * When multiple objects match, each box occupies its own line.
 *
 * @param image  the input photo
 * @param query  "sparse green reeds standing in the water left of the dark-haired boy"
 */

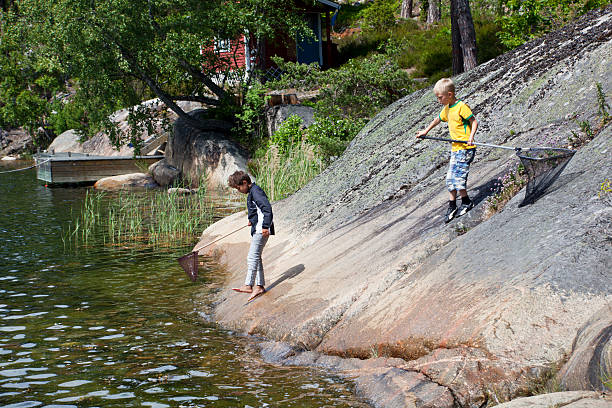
xmin=63 ymin=184 xmax=213 ymax=247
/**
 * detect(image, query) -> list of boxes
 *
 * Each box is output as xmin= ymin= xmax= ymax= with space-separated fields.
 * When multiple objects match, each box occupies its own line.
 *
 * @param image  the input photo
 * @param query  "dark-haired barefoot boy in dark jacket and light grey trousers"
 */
xmin=228 ymin=171 xmax=274 ymax=300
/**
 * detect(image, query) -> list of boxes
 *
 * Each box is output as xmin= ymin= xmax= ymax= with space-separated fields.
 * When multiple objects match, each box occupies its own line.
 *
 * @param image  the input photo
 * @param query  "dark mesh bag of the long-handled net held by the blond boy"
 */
xmin=516 ymin=147 xmax=575 ymax=207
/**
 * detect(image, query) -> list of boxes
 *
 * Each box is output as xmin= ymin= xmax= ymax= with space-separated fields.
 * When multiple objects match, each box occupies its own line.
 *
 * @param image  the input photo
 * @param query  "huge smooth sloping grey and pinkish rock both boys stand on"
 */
xmin=196 ymin=6 xmax=612 ymax=407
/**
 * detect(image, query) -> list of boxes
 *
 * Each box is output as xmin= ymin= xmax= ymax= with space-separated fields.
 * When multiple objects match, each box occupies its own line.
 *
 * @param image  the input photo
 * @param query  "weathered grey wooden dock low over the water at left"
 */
xmin=34 ymin=153 xmax=164 ymax=184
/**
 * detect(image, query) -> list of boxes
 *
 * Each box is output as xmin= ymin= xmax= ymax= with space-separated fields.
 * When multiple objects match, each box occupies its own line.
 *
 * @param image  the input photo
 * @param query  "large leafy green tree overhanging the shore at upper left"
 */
xmin=2 ymin=0 xmax=305 ymax=149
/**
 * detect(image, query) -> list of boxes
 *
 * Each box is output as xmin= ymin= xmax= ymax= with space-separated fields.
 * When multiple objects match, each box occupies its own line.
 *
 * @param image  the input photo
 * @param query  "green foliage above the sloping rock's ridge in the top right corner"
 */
xmin=498 ymin=0 xmax=610 ymax=48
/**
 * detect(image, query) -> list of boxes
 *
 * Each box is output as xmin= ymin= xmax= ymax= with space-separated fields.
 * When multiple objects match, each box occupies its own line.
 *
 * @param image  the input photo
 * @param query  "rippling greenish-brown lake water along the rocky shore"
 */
xmin=0 ymin=162 xmax=367 ymax=407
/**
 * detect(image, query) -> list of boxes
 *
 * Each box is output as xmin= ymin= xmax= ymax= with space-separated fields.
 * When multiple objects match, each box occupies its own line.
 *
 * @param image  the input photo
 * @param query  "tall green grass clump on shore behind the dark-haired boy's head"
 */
xmin=249 ymin=141 xmax=325 ymax=201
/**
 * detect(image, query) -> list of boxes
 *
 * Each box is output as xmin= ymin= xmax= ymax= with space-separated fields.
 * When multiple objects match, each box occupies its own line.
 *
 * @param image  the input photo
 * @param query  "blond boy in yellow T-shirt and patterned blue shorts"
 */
xmin=417 ymin=78 xmax=478 ymax=222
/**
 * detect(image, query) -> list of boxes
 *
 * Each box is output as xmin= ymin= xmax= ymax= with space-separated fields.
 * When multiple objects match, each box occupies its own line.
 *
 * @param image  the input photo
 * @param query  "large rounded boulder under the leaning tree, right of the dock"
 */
xmin=165 ymin=109 xmax=248 ymax=188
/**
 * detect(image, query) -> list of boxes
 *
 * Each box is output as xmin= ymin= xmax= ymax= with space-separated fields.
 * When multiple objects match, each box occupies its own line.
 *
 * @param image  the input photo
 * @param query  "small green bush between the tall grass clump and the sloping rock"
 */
xmin=306 ymin=116 xmax=365 ymax=163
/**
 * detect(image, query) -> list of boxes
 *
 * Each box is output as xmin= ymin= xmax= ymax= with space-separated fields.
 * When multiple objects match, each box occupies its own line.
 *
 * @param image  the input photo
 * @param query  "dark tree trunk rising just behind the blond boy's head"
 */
xmin=451 ymin=0 xmax=478 ymax=75
